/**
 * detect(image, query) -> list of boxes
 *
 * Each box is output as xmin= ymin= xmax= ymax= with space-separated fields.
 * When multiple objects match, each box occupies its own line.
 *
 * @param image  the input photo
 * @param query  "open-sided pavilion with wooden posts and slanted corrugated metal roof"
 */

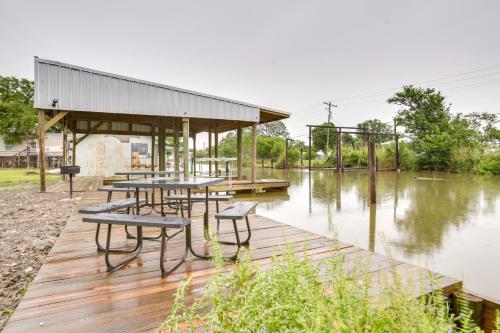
xmin=34 ymin=57 xmax=290 ymax=192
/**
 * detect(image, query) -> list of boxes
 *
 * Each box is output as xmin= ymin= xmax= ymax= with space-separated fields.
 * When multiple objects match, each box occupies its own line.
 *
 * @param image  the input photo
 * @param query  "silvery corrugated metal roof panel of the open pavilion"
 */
xmin=35 ymin=57 xmax=289 ymax=122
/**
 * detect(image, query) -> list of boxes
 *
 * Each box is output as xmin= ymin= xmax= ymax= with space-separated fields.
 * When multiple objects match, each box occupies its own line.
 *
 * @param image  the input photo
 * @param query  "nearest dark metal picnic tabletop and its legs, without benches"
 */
xmin=113 ymin=177 xmax=224 ymax=259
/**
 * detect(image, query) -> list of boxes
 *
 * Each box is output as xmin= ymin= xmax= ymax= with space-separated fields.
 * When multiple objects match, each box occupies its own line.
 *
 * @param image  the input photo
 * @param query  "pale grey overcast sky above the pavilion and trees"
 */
xmin=0 ymin=0 xmax=500 ymax=140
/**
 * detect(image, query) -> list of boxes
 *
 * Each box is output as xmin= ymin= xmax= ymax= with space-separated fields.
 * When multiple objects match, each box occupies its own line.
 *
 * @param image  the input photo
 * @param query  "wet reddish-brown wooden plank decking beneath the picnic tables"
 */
xmin=4 ymin=179 xmax=461 ymax=333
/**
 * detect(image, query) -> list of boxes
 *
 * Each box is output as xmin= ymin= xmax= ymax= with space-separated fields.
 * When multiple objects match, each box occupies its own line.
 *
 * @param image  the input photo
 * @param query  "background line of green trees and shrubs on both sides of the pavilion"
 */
xmin=0 ymin=76 xmax=500 ymax=174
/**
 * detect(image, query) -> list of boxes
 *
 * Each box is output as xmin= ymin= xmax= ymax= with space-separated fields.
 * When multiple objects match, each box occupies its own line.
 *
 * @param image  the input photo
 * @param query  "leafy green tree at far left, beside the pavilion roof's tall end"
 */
xmin=0 ymin=76 xmax=38 ymax=144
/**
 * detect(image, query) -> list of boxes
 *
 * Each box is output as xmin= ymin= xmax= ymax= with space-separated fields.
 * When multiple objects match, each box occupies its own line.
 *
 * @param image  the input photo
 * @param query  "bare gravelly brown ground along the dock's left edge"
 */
xmin=0 ymin=189 xmax=75 ymax=331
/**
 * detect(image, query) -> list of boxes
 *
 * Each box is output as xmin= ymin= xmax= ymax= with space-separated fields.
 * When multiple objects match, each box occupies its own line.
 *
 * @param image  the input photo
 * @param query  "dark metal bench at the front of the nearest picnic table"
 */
xmin=83 ymin=213 xmax=191 ymax=278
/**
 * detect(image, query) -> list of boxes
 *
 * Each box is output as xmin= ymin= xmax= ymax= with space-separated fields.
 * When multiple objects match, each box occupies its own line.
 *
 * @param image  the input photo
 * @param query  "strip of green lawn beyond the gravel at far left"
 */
xmin=0 ymin=168 xmax=61 ymax=189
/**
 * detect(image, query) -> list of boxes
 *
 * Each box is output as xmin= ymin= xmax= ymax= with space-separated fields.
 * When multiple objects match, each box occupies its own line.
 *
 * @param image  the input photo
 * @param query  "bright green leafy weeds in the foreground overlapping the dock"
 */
xmin=159 ymin=241 xmax=477 ymax=333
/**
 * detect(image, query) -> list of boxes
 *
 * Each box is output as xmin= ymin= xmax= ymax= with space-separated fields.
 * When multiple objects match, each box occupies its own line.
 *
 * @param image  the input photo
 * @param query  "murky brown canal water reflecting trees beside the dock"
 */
xmin=239 ymin=169 xmax=500 ymax=299
